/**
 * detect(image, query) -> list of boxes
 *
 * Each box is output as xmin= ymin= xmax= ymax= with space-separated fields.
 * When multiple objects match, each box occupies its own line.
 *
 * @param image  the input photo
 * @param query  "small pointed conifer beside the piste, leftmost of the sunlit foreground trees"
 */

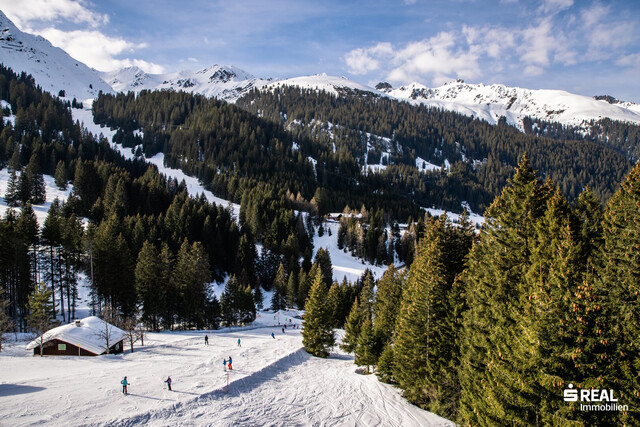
xmin=302 ymin=270 xmax=335 ymax=357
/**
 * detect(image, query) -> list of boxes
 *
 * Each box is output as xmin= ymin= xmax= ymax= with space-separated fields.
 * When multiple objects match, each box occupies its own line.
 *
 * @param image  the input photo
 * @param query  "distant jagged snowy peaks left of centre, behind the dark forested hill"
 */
xmin=101 ymin=65 xmax=271 ymax=102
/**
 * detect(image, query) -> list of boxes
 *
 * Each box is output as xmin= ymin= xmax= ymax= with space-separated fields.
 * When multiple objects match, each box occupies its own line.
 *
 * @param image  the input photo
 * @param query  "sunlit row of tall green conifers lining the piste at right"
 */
xmin=306 ymin=157 xmax=640 ymax=426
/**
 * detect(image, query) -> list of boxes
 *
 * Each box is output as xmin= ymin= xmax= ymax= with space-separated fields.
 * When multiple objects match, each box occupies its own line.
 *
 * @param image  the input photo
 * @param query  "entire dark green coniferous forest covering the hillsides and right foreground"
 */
xmin=0 ymin=67 xmax=640 ymax=426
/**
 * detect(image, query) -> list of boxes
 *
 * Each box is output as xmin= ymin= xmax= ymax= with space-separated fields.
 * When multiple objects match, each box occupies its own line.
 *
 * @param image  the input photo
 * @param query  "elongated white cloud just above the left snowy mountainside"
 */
xmin=38 ymin=28 xmax=164 ymax=73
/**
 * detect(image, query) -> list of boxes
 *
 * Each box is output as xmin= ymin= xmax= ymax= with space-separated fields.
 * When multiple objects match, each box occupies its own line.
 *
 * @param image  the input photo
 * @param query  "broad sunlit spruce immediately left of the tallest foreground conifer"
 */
xmin=393 ymin=215 xmax=458 ymax=418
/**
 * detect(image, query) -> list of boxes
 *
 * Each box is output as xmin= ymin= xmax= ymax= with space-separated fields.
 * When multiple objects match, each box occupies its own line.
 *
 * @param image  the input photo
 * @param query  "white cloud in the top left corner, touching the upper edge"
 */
xmin=0 ymin=0 xmax=109 ymax=28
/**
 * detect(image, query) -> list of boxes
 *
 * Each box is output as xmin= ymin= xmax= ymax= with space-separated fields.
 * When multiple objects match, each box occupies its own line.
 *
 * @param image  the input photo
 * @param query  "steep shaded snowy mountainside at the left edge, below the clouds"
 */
xmin=0 ymin=11 xmax=112 ymax=100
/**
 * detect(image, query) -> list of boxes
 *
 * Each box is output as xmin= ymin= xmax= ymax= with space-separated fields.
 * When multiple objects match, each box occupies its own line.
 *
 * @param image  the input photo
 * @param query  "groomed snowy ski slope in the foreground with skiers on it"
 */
xmin=0 ymin=320 xmax=454 ymax=427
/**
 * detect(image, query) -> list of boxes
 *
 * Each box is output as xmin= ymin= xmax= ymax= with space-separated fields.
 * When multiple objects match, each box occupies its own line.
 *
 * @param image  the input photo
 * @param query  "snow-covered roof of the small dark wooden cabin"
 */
xmin=27 ymin=316 xmax=126 ymax=354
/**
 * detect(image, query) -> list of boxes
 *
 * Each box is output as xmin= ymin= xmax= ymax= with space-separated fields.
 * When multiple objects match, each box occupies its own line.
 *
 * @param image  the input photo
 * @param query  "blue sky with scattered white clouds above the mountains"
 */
xmin=0 ymin=0 xmax=640 ymax=102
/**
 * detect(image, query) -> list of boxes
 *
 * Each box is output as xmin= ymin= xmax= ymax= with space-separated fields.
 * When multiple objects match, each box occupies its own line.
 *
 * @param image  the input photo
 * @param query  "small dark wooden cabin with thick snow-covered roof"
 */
xmin=27 ymin=316 xmax=126 ymax=356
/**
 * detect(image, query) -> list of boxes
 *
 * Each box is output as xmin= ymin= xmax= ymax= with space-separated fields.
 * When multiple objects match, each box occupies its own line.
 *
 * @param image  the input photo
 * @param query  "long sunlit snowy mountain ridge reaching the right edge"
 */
xmin=376 ymin=80 xmax=640 ymax=128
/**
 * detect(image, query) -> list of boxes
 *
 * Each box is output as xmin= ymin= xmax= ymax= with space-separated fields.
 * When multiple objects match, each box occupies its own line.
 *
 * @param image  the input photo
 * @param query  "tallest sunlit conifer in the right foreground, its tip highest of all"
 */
xmin=459 ymin=156 xmax=549 ymax=425
